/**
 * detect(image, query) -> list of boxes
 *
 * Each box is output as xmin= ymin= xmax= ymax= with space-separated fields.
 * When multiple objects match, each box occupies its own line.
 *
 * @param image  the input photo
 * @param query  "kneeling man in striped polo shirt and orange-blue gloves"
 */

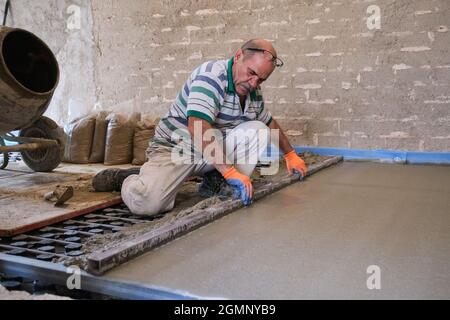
xmin=93 ymin=39 xmax=307 ymax=215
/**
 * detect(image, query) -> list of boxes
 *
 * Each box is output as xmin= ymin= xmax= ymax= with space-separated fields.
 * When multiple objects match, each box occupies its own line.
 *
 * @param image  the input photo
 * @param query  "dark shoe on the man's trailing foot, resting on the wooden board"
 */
xmin=92 ymin=168 xmax=141 ymax=192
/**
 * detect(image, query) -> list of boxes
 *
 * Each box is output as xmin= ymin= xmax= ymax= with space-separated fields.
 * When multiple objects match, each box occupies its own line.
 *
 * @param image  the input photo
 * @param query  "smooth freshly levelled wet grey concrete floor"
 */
xmin=106 ymin=162 xmax=450 ymax=299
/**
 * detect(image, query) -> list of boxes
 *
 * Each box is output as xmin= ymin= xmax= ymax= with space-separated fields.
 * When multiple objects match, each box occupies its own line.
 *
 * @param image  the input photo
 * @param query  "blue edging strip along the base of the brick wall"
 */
xmin=295 ymin=146 xmax=450 ymax=164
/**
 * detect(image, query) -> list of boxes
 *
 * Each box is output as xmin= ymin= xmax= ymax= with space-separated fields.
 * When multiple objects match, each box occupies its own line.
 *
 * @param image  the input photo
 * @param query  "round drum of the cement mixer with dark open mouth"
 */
xmin=0 ymin=27 xmax=59 ymax=135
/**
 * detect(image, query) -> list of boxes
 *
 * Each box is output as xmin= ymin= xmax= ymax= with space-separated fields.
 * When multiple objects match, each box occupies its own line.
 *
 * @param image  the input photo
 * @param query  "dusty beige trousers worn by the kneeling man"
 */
xmin=122 ymin=121 xmax=270 ymax=215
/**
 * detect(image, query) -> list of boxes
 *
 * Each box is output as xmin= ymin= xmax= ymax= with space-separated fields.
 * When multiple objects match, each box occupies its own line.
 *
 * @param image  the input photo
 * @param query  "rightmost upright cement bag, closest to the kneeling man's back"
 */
xmin=131 ymin=117 xmax=159 ymax=166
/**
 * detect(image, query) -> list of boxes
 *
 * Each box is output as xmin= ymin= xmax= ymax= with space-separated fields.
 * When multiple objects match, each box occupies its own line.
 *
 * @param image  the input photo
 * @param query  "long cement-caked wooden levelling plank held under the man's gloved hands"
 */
xmin=88 ymin=157 xmax=342 ymax=275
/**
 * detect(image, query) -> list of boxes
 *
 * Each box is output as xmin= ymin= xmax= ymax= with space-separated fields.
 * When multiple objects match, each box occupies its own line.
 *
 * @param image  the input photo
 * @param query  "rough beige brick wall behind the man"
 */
xmin=80 ymin=0 xmax=450 ymax=151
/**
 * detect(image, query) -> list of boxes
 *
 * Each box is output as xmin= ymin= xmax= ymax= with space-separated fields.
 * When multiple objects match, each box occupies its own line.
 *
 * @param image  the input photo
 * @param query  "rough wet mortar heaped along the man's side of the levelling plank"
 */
xmin=60 ymin=153 xmax=330 ymax=270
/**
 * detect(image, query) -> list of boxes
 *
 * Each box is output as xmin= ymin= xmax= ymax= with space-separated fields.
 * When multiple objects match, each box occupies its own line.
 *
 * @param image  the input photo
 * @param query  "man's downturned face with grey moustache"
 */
xmin=233 ymin=50 xmax=275 ymax=97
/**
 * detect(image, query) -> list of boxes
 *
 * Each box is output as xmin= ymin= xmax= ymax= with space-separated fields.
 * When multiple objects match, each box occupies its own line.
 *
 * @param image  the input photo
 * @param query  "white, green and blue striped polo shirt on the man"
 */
xmin=153 ymin=58 xmax=272 ymax=146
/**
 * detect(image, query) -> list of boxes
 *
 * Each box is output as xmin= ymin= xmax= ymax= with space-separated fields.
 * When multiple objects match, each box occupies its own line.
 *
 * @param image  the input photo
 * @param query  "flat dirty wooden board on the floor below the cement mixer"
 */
xmin=0 ymin=167 xmax=122 ymax=237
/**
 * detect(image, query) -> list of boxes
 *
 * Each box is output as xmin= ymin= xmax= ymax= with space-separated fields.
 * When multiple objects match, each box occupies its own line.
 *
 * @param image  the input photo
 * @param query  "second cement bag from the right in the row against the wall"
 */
xmin=104 ymin=113 xmax=140 ymax=165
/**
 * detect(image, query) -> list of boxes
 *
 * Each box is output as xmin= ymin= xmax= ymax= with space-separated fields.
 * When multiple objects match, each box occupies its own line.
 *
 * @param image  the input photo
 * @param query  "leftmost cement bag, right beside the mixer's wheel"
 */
xmin=63 ymin=115 xmax=95 ymax=164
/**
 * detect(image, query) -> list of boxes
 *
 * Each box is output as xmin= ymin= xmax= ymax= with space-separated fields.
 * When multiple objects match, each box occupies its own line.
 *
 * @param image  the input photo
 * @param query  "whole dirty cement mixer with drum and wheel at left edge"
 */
xmin=0 ymin=27 xmax=64 ymax=172
